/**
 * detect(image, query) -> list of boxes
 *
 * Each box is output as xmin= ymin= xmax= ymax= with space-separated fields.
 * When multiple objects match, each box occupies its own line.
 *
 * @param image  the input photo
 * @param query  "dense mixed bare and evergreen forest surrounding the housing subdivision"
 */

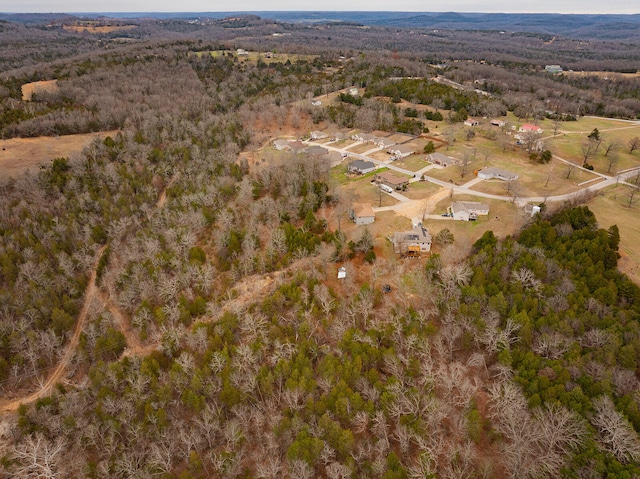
xmin=0 ymin=13 xmax=640 ymax=478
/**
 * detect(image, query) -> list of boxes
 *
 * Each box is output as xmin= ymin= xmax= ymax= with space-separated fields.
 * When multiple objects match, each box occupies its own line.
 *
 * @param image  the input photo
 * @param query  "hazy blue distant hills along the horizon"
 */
xmin=0 ymin=11 xmax=640 ymax=40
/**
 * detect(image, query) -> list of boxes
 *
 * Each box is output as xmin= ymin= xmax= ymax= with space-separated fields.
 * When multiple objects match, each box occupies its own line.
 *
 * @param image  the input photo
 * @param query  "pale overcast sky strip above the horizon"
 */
xmin=5 ymin=0 xmax=640 ymax=13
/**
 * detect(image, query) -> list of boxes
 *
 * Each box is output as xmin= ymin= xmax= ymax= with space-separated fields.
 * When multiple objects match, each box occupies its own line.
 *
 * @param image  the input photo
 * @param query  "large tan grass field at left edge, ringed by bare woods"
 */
xmin=0 ymin=131 xmax=117 ymax=180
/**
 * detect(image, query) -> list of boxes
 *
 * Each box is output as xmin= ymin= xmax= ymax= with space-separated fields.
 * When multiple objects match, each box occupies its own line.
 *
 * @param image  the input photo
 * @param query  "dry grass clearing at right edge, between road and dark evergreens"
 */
xmin=587 ymin=186 xmax=640 ymax=285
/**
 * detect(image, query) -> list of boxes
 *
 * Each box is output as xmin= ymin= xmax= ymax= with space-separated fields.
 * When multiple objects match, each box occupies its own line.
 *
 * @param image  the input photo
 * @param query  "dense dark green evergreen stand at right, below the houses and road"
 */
xmin=462 ymin=207 xmax=640 ymax=477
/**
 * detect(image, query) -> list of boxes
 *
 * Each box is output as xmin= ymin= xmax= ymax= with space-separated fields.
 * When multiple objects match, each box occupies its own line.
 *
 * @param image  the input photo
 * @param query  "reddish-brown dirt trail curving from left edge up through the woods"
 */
xmin=0 ymin=245 xmax=107 ymax=412
